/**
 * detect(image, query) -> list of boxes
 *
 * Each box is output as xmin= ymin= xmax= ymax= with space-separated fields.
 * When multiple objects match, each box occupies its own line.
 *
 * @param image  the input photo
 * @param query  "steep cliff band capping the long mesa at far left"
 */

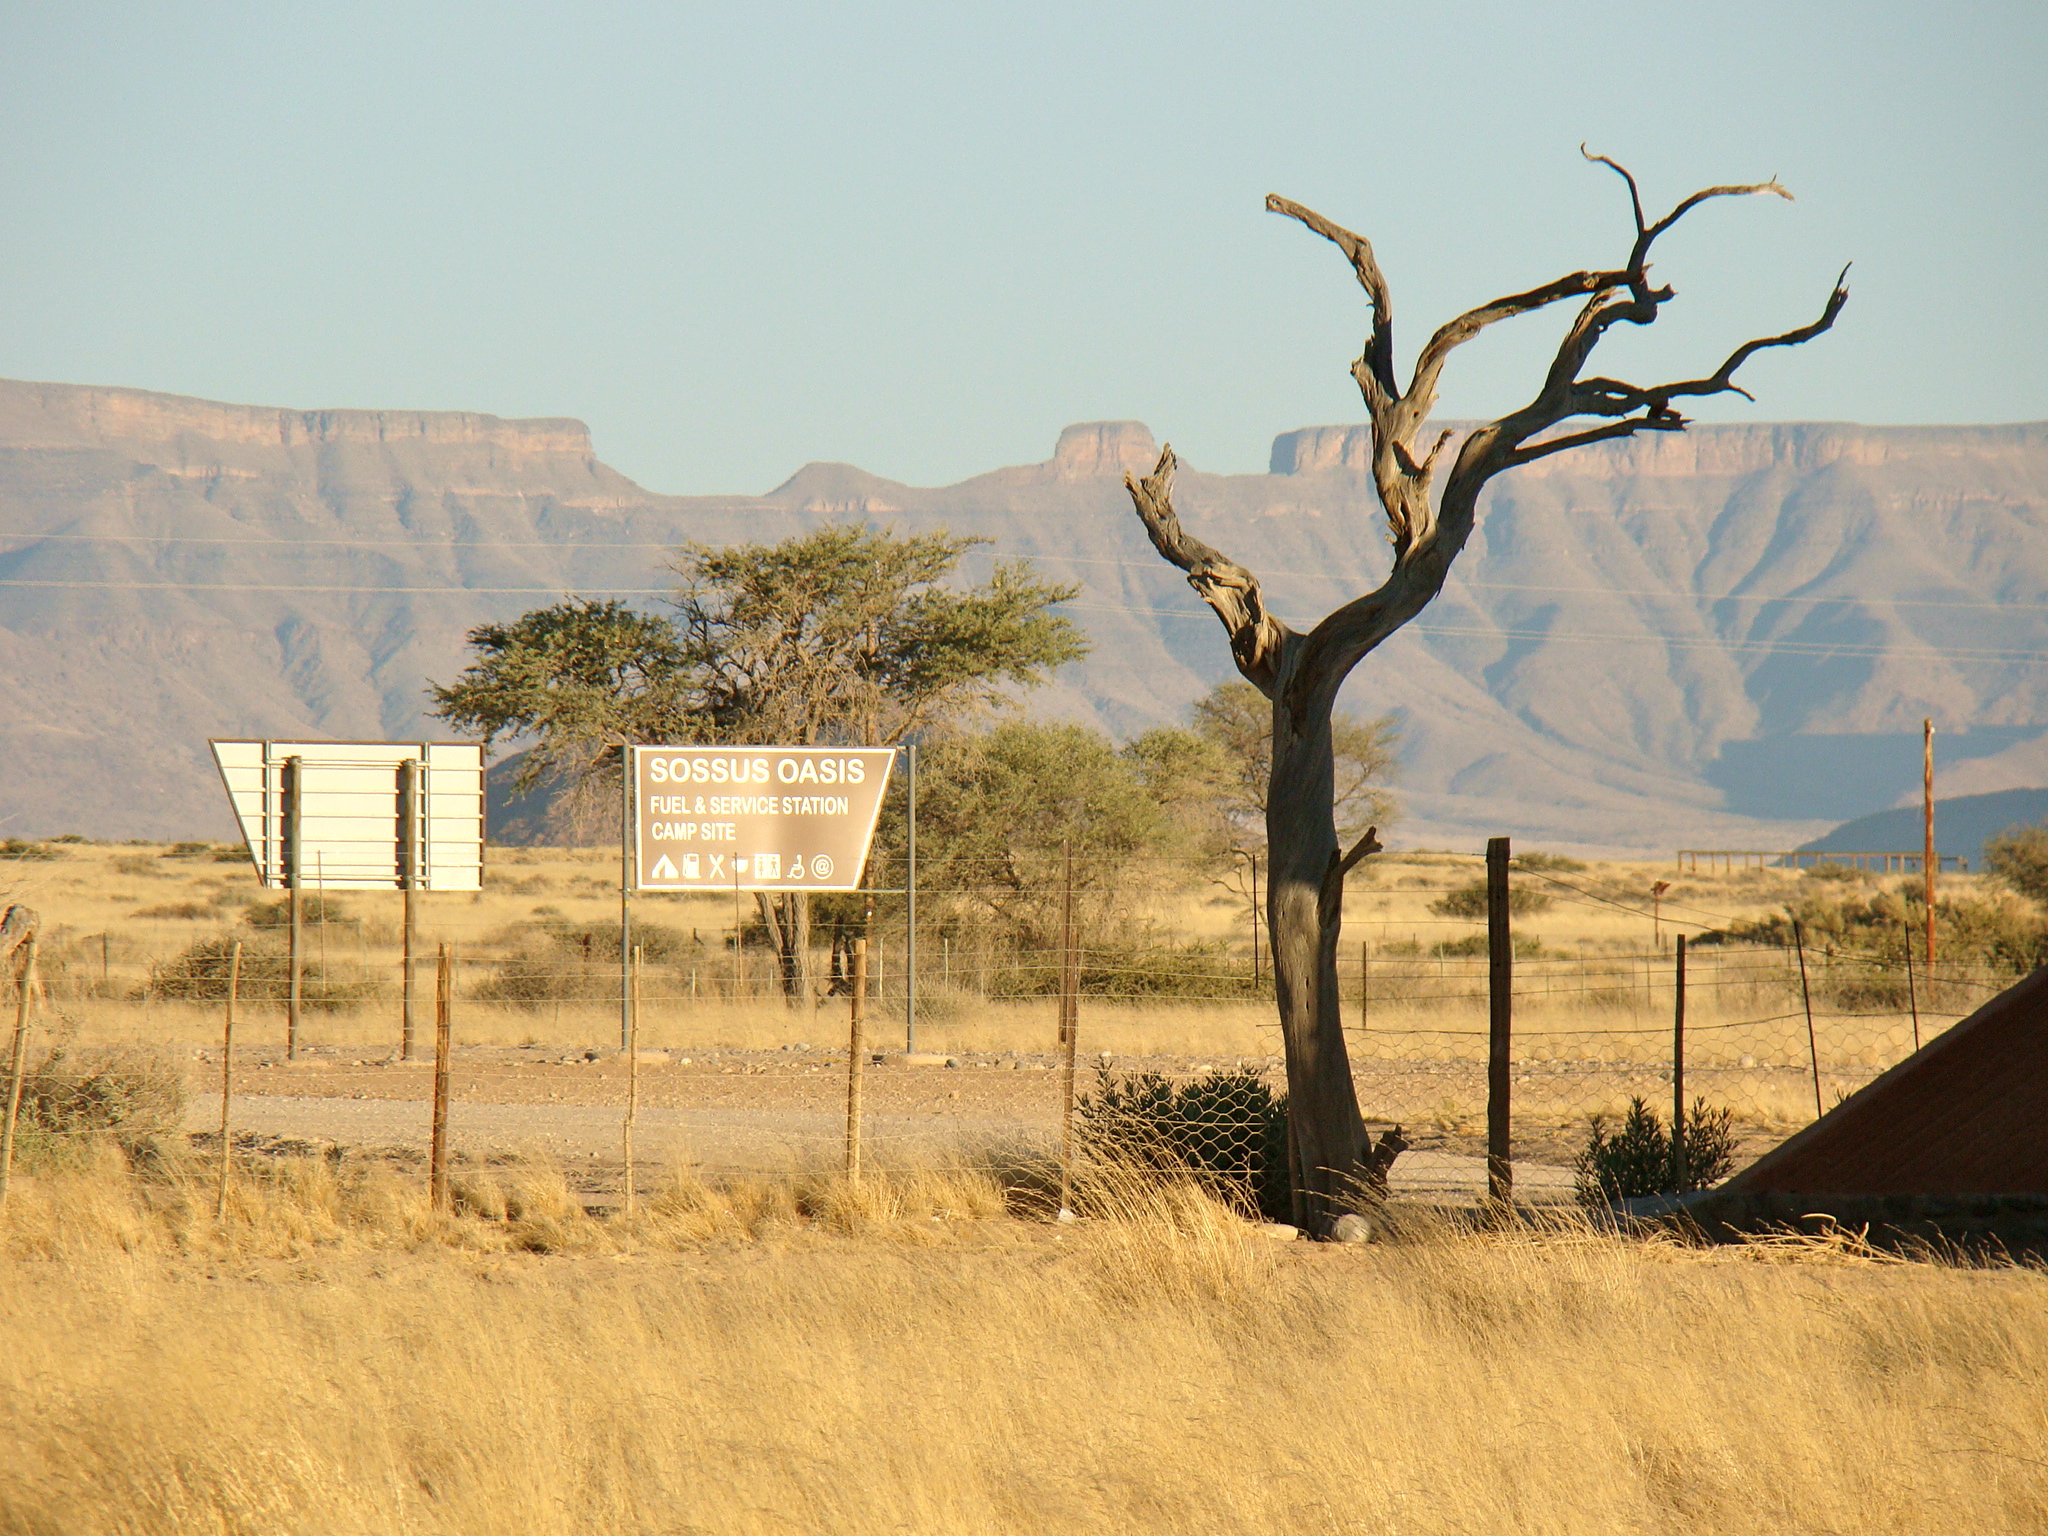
xmin=0 ymin=381 xmax=594 ymax=461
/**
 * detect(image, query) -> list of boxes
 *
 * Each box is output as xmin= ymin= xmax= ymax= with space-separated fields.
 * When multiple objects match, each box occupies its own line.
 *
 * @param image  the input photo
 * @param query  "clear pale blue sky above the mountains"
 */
xmin=0 ymin=0 xmax=2048 ymax=492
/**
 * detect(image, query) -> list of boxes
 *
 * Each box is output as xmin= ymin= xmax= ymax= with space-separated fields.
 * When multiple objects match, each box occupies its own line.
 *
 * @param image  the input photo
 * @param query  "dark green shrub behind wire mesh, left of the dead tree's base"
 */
xmin=1075 ymin=1067 xmax=1292 ymax=1221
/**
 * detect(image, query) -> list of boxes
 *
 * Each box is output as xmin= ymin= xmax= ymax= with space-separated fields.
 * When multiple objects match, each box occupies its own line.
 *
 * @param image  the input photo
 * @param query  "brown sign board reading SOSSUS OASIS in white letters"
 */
xmin=633 ymin=748 xmax=895 ymax=891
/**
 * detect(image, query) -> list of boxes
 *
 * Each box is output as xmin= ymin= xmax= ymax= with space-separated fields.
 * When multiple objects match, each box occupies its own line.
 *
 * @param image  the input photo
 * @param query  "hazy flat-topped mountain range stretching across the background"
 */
xmin=0 ymin=383 xmax=2048 ymax=852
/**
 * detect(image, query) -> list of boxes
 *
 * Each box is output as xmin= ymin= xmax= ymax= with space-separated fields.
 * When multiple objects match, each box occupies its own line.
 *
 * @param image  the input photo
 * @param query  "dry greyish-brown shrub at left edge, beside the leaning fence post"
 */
xmin=14 ymin=1042 xmax=184 ymax=1169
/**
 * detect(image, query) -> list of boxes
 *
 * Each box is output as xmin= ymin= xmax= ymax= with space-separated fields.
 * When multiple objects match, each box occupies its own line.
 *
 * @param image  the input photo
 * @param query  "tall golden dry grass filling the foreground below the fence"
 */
xmin=0 ymin=1165 xmax=2048 ymax=1536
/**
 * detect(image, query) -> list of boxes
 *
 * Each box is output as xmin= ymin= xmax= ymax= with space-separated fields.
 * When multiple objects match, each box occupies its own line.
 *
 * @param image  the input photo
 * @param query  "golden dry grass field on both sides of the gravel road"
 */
xmin=0 ymin=846 xmax=2048 ymax=1536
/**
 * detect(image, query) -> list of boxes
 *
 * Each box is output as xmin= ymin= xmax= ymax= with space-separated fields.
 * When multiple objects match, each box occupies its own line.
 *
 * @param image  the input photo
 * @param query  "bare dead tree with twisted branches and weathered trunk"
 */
xmin=1124 ymin=150 xmax=1847 ymax=1231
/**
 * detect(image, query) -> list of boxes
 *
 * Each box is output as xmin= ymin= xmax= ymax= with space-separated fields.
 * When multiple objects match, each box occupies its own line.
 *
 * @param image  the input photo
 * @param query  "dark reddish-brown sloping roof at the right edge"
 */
xmin=1720 ymin=967 xmax=2048 ymax=1194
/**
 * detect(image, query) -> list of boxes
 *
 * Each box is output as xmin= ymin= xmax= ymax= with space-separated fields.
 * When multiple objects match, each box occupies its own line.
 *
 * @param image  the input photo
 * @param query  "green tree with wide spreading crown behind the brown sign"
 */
xmin=432 ymin=524 xmax=1087 ymax=1006
